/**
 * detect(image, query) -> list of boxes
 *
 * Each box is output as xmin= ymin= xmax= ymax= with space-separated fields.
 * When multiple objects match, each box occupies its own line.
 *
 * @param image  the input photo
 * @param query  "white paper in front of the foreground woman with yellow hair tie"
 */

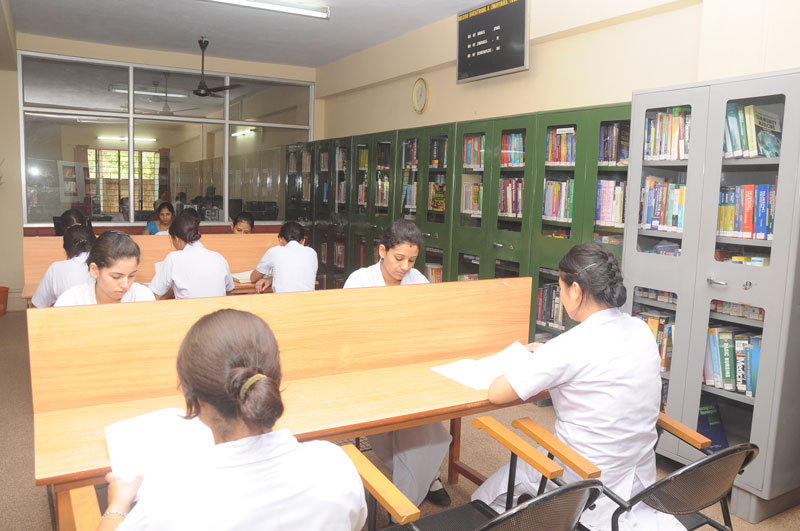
xmin=105 ymin=408 xmax=214 ymax=481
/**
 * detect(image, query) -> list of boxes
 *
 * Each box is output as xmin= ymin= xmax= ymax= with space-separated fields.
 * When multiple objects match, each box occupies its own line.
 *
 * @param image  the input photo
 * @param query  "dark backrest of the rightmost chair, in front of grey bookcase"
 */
xmin=630 ymin=443 xmax=758 ymax=514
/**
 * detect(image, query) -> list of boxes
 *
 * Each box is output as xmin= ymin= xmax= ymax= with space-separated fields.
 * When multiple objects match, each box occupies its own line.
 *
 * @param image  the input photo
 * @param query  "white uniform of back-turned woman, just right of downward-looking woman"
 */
xmin=150 ymin=241 xmax=234 ymax=299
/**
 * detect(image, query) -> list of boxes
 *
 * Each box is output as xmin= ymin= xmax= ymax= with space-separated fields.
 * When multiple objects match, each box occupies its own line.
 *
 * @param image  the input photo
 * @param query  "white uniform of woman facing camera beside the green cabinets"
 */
xmin=344 ymin=262 xmax=451 ymax=505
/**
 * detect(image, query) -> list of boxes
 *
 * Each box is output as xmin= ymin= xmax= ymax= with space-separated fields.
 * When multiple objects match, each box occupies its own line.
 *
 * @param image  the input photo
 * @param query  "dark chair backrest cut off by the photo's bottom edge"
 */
xmin=479 ymin=479 xmax=603 ymax=531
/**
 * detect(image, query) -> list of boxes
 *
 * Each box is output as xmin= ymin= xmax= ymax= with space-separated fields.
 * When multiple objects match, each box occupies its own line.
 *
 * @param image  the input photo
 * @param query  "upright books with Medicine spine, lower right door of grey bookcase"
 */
xmin=703 ymin=326 xmax=761 ymax=397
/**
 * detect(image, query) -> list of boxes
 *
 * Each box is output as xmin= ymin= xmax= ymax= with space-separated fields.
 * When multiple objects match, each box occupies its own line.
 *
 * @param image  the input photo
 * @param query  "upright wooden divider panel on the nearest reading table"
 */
xmin=28 ymin=277 xmax=531 ymax=413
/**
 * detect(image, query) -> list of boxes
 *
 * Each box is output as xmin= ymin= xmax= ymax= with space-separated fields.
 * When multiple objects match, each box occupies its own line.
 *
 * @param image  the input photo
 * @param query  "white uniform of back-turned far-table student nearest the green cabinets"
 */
xmin=256 ymin=241 xmax=317 ymax=293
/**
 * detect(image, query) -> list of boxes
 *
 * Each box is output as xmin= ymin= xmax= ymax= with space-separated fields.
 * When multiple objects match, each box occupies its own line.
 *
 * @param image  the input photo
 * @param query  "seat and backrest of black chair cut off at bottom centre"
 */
xmin=389 ymin=479 xmax=603 ymax=531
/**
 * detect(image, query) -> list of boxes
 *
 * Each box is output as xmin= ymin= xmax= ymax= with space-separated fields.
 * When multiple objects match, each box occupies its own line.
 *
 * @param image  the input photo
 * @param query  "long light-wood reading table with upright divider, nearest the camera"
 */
xmin=28 ymin=278 xmax=531 ymax=528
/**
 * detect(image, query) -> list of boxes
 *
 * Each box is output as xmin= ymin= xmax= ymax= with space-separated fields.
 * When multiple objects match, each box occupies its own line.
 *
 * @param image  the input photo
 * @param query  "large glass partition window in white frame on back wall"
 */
xmin=20 ymin=52 xmax=312 ymax=224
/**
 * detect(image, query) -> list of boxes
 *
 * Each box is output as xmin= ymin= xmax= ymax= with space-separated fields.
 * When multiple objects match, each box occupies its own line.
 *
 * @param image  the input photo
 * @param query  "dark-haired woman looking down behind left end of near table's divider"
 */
xmin=55 ymin=230 xmax=155 ymax=306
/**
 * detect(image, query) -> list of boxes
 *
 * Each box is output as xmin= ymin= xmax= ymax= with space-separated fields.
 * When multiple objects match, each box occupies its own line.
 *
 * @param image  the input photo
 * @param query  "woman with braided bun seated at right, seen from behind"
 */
xmin=472 ymin=243 xmax=683 ymax=530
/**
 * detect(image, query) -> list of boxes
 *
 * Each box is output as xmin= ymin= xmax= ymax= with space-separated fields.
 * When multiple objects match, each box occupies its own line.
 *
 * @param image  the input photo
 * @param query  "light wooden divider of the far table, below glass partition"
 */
xmin=21 ymin=234 xmax=278 ymax=300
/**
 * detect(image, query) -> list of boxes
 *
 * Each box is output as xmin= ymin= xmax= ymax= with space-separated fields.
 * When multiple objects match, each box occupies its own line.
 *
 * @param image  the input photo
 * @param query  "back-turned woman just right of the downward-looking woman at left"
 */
xmin=150 ymin=215 xmax=234 ymax=299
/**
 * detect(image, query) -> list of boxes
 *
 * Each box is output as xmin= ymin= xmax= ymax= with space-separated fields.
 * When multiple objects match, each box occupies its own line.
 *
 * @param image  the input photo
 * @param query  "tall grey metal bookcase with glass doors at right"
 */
xmin=623 ymin=71 xmax=800 ymax=523
